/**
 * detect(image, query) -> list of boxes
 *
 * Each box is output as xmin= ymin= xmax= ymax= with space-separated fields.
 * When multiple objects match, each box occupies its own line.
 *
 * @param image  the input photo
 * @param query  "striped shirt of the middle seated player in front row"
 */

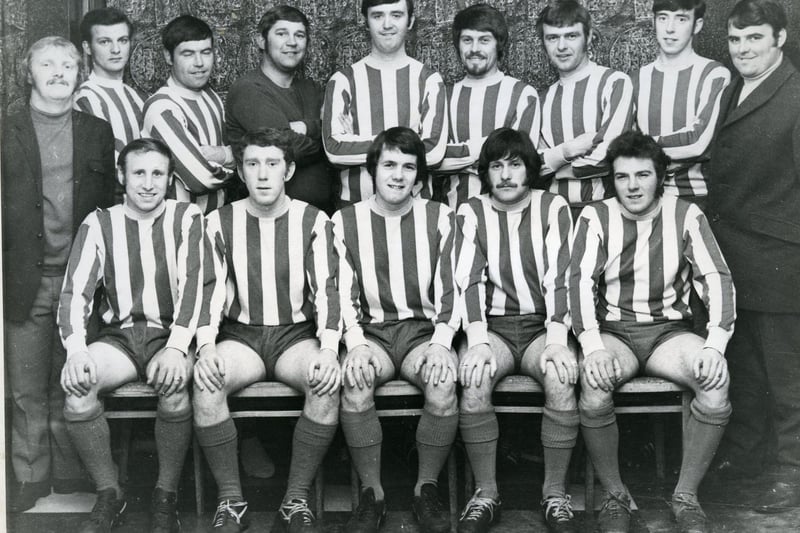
xmin=333 ymin=197 xmax=459 ymax=349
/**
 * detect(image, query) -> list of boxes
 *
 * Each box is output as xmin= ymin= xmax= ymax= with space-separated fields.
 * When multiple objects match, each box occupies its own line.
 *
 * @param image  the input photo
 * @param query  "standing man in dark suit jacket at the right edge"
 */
xmin=708 ymin=0 xmax=800 ymax=512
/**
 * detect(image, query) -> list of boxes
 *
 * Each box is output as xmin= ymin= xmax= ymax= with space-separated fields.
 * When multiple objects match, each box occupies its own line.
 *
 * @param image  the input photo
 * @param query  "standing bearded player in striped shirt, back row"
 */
xmin=439 ymin=4 xmax=541 ymax=209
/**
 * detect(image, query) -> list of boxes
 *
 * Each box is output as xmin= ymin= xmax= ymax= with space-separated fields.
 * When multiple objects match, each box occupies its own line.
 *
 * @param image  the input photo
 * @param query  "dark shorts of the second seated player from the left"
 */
xmin=217 ymin=321 xmax=317 ymax=380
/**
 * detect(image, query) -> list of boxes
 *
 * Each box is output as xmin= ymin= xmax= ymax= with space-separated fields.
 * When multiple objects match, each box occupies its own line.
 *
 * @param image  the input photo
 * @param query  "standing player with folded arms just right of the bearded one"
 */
xmin=536 ymin=0 xmax=633 ymax=217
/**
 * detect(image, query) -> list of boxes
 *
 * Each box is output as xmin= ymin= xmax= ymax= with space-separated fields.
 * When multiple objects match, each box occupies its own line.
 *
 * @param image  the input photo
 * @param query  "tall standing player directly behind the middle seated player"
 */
xmin=322 ymin=0 xmax=447 ymax=205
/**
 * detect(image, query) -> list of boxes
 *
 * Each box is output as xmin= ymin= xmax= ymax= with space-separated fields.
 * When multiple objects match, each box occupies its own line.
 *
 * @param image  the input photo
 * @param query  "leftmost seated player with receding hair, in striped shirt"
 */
xmin=58 ymin=139 xmax=203 ymax=533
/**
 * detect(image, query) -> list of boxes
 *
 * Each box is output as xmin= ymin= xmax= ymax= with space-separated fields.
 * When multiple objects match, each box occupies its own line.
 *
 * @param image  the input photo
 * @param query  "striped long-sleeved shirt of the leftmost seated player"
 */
xmin=58 ymin=200 xmax=203 ymax=354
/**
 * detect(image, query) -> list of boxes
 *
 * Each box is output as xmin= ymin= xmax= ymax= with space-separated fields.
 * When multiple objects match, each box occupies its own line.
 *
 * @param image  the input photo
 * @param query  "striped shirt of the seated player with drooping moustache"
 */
xmin=456 ymin=190 xmax=572 ymax=346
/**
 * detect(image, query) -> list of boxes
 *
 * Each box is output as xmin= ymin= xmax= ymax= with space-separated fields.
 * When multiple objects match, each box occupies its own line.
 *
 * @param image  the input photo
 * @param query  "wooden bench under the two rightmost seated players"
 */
xmin=464 ymin=375 xmax=692 ymax=511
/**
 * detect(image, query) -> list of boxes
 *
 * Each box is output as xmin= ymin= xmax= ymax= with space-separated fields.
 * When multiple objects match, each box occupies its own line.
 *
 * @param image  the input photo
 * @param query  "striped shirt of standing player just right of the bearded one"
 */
xmin=540 ymin=62 xmax=633 ymax=205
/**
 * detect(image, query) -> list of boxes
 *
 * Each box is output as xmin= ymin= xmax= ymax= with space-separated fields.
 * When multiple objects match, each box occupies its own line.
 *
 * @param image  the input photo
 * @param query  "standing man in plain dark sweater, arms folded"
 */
xmin=225 ymin=6 xmax=335 ymax=214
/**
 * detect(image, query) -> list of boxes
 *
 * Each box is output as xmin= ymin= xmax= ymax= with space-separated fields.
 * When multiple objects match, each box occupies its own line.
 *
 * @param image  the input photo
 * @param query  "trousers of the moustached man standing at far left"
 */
xmin=5 ymin=276 xmax=82 ymax=482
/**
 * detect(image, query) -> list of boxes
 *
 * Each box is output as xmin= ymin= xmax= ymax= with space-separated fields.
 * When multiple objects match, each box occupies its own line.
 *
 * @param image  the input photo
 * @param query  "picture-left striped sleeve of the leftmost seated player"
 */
xmin=57 ymin=213 xmax=105 ymax=356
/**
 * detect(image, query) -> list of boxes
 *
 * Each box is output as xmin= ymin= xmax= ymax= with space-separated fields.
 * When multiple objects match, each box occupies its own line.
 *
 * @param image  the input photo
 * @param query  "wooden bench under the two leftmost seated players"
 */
xmin=106 ymin=381 xmax=324 ymax=517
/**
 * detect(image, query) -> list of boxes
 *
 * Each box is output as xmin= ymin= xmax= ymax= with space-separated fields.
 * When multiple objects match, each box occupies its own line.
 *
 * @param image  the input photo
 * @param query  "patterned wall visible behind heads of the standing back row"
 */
xmin=0 ymin=0 xmax=800 ymax=109
